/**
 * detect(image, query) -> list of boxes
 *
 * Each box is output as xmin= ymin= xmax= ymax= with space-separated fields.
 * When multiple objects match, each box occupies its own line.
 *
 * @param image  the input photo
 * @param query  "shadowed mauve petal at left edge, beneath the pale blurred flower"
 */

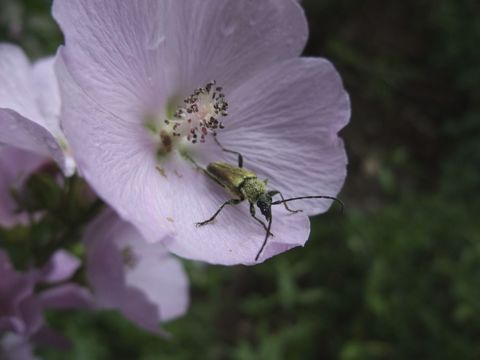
xmin=0 ymin=146 xmax=48 ymax=227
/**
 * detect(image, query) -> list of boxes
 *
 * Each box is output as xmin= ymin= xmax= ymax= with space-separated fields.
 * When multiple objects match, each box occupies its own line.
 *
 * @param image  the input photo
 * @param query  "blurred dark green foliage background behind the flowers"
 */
xmin=0 ymin=0 xmax=480 ymax=360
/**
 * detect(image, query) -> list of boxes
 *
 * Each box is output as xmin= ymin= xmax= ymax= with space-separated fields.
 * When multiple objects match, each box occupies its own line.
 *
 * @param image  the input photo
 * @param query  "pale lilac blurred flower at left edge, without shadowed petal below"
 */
xmin=0 ymin=43 xmax=74 ymax=175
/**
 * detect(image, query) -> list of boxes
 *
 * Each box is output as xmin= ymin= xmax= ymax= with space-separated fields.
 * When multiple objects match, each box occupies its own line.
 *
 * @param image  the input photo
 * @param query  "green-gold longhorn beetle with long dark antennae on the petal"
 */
xmin=195 ymin=138 xmax=344 ymax=261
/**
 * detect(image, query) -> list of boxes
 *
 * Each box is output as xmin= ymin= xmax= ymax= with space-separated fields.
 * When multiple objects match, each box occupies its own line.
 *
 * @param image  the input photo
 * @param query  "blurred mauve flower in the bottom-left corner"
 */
xmin=0 ymin=250 xmax=93 ymax=350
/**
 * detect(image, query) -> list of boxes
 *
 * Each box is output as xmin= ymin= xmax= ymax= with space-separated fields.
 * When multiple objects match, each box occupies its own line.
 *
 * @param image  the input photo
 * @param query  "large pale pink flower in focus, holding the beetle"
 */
xmin=53 ymin=0 xmax=350 ymax=264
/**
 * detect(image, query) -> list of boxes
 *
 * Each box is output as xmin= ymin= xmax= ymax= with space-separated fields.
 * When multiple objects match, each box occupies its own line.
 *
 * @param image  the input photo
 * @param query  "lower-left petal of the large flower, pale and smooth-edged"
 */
xmin=57 ymin=56 xmax=173 ymax=241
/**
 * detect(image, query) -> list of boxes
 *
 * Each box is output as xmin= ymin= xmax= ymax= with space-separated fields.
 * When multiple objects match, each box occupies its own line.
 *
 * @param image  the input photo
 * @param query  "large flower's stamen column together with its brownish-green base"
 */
xmin=150 ymin=80 xmax=228 ymax=156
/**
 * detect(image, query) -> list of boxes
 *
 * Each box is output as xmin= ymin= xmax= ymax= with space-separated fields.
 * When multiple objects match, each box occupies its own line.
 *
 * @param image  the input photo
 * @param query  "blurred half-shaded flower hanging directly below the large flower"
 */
xmin=84 ymin=209 xmax=189 ymax=333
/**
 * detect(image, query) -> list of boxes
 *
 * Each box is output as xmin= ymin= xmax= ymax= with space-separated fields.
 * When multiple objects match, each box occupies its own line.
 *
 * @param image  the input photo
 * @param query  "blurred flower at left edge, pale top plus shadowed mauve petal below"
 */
xmin=0 ymin=44 xmax=75 ymax=226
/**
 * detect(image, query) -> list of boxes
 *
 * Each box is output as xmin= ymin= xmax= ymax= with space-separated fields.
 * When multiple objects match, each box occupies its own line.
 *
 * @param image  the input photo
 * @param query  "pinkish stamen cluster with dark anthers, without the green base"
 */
xmin=164 ymin=81 xmax=228 ymax=144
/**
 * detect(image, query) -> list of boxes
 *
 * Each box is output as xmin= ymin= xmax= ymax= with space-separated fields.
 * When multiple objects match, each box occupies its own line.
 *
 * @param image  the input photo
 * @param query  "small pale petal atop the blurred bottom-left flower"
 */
xmin=40 ymin=250 xmax=81 ymax=283
